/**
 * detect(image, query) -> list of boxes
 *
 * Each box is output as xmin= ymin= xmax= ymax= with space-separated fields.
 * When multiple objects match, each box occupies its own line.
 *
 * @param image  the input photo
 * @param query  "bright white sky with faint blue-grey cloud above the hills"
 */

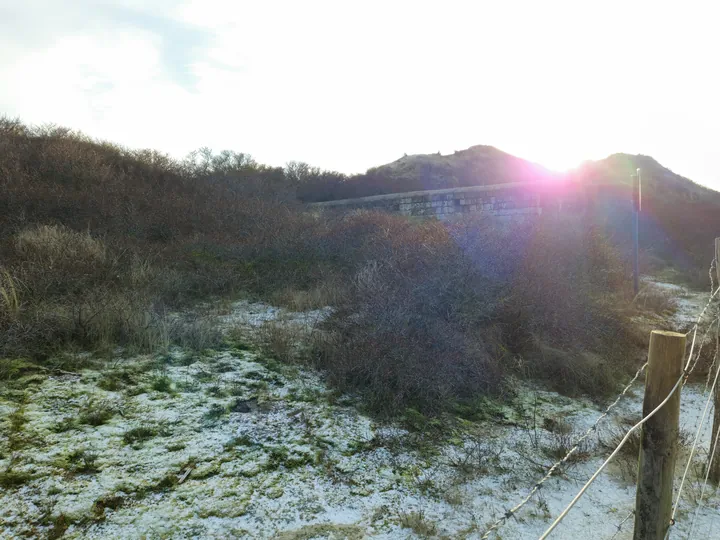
xmin=0 ymin=0 xmax=720 ymax=189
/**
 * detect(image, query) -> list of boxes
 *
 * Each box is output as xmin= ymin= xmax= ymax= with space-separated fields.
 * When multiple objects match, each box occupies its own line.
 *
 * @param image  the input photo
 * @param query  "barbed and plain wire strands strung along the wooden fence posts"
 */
xmin=481 ymin=259 xmax=720 ymax=540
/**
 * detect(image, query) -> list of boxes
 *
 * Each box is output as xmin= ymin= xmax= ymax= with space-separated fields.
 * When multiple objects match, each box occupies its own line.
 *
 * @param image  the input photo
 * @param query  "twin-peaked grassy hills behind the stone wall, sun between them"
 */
xmin=298 ymin=146 xmax=720 ymax=286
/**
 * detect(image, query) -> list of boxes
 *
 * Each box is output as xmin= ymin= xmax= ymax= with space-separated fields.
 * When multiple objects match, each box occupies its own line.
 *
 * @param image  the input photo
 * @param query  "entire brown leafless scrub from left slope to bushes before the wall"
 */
xmin=0 ymin=119 xmax=648 ymax=421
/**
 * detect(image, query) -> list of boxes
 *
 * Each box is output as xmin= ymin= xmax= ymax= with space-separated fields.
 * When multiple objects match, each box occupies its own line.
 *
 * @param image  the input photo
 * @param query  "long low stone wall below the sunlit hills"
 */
xmin=310 ymin=183 xmax=583 ymax=219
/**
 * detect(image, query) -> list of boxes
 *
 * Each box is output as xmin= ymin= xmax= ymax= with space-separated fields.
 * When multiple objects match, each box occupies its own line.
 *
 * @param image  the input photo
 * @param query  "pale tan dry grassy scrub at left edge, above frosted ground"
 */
xmin=0 ymin=226 xmax=173 ymax=355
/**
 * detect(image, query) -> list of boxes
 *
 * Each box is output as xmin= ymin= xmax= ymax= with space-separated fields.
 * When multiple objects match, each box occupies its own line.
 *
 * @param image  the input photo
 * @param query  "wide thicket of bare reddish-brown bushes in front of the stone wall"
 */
xmin=317 ymin=213 xmax=639 ymax=413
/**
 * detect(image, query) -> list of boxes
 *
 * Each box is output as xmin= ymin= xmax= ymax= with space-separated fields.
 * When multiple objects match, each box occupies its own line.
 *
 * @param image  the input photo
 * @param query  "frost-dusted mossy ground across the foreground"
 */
xmin=0 ymin=284 xmax=720 ymax=539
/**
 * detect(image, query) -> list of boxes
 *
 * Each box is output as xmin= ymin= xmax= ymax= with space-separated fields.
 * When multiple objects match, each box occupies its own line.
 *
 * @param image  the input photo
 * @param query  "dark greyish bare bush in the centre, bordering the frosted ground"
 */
xmin=318 ymin=216 xmax=506 ymax=414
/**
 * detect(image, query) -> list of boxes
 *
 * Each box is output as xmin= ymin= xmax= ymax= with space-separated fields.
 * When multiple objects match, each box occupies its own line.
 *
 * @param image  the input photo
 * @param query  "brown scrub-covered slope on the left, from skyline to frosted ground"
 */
xmin=0 ymin=119 xmax=300 ymax=357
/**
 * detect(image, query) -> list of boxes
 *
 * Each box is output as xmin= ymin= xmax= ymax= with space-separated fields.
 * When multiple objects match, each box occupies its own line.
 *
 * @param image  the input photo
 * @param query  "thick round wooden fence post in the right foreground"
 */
xmin=633 ymin=330 xmax=685 ymax=540
